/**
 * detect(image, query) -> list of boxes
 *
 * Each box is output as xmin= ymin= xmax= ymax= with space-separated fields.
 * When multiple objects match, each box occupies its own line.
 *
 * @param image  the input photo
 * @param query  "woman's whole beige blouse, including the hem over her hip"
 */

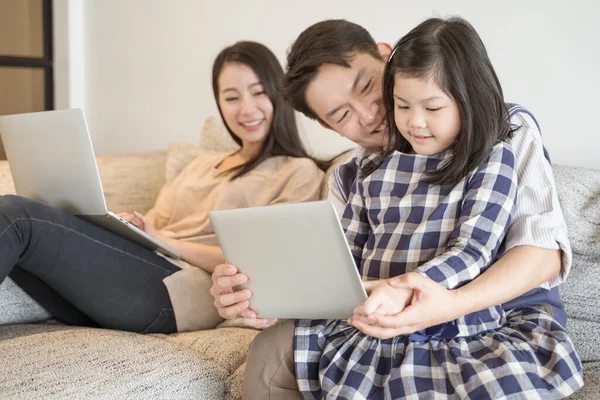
xmin=146 ymin=153 xmax=323 ymax=332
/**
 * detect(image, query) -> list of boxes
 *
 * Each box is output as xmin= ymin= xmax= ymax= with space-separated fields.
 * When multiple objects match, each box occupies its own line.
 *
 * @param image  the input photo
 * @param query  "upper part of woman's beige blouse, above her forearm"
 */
xmin=146 ymin=154 xmax=323 ymax=246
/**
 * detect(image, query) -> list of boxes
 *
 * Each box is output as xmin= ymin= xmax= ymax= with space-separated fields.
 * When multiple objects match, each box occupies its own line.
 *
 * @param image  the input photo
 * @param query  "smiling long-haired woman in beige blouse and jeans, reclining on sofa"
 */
xmin=0 ymin=42 xmax=323 ymax=333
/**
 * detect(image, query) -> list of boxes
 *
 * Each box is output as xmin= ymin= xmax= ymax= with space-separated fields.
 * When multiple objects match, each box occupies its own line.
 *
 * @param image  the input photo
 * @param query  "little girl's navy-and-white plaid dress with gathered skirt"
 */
xmin=294 ymin=143 xmax=583 ymax=399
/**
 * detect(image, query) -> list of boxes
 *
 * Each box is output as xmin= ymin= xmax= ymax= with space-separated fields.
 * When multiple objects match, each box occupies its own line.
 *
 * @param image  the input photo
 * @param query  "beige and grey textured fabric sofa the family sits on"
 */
xmin=0 ymin=118 xmax=600 ymax=399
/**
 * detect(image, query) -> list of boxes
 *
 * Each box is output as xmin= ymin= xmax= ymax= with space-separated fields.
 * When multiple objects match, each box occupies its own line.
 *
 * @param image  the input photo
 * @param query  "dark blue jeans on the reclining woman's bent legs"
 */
xmin=0 ymin=196 xmax=179 ymax=333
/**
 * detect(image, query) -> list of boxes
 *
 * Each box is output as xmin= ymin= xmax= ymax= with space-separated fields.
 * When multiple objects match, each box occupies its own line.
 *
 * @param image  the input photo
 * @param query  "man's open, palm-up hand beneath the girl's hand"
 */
xmin=352 ymin=272 xmax=465 ymax=339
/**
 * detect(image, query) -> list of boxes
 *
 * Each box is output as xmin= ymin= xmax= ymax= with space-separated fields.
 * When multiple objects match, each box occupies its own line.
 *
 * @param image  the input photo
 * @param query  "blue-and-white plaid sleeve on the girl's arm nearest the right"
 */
xmin=416 ymin=143 xmax=517 ymax=289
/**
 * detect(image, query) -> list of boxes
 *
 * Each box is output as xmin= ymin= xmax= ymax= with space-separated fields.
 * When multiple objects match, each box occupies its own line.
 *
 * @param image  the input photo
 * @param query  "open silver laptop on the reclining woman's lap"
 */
xmin=0 ymin=109 xmax=179 ymax=258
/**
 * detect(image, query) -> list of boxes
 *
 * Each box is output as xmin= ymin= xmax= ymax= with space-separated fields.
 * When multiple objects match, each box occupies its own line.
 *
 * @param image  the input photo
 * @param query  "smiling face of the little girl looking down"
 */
xmin=394 ymin=74 xmax=461 ymax=156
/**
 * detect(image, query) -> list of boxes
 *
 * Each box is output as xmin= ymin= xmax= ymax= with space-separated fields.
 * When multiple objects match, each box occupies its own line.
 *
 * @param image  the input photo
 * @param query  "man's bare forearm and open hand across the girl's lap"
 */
xmin=354 ymin=246 xmax=561 ymax=339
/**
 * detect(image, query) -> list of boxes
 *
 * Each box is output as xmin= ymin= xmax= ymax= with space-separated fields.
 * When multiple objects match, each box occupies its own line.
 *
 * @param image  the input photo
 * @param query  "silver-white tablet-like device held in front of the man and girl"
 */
xmin=208 ymin=201 xmax=367 ymax=319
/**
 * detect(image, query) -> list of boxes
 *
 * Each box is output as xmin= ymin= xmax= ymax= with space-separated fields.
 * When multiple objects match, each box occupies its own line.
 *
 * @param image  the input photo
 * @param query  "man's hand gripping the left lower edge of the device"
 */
xmin=210 ymin=264 xmax=277 ymax=328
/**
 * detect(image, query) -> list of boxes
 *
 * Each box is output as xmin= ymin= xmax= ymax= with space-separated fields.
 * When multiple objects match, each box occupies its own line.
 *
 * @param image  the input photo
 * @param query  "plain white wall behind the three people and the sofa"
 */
xmin=55 ymin=0 xmax=600 ymax=168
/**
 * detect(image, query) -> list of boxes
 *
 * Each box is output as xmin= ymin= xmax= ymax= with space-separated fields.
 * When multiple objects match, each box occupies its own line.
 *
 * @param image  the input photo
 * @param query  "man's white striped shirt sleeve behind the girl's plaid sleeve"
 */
xmin=504 ymin=113 xmax=573 ymax=289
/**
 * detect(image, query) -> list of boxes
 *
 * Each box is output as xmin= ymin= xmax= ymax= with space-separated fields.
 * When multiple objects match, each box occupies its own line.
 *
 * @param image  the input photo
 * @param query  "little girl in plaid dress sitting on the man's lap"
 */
xmin=294 ymin=19 xmax=583 ymax=399
